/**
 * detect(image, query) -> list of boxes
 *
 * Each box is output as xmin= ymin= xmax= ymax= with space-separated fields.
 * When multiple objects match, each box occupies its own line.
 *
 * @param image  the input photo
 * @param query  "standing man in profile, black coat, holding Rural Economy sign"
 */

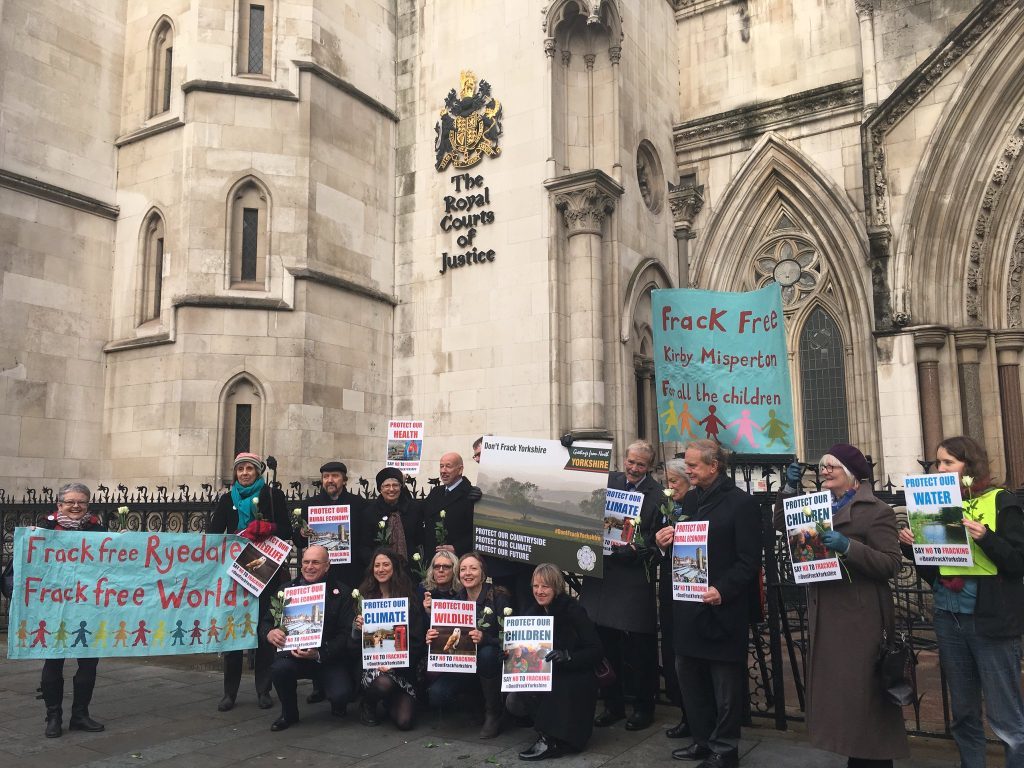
xmin=672 ymin=440 xmax=761 ymax=768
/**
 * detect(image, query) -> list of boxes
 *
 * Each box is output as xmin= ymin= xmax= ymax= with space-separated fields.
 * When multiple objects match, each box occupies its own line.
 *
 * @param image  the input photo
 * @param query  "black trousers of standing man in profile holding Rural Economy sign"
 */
xmin=676 ymin=656 xmax=746 ymax=754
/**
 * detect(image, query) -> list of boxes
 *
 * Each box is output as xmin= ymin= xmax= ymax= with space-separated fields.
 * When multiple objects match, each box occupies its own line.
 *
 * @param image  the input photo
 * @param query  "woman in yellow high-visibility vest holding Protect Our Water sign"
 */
xmin=900 ymin=436 xmax=1024 ymax=768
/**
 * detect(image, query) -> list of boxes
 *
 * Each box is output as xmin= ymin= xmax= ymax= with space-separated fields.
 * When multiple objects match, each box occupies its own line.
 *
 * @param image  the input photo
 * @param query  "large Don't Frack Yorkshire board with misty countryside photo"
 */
xmin=473 ymin=435 xmax=611 ymax=578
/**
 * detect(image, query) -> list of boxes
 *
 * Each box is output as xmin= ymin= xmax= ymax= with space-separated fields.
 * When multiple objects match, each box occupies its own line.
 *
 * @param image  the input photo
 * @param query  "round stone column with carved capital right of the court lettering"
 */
xmin=545 ymin=170 xmax=623 ymax=434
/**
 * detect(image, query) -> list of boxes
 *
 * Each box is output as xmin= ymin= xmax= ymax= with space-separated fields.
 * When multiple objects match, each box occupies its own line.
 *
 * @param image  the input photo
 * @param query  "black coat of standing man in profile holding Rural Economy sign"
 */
xmin=672 ymin=476 xmax=761 ymax=662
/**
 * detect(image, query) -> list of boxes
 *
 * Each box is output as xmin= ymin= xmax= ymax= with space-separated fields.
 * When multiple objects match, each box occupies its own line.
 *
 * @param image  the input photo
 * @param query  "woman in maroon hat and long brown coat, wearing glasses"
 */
xmin=775 ymin=442 xmax=909 ymax=768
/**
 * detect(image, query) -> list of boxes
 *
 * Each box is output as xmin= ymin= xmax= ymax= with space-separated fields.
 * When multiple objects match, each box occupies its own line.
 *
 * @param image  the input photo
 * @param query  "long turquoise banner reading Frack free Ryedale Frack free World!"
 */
xmin=7 ymin=528 xmax=259 ymax=658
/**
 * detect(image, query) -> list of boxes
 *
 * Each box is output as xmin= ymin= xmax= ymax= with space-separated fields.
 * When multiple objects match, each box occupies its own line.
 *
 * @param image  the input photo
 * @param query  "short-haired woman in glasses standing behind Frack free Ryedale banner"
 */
xmin=40 ymin=482 xmax=106 ymax=738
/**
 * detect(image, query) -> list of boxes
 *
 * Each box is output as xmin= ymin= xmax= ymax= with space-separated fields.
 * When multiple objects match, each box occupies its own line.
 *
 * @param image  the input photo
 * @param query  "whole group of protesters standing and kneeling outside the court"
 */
xmin=24 ymin=437 xmax=1024 ymax=768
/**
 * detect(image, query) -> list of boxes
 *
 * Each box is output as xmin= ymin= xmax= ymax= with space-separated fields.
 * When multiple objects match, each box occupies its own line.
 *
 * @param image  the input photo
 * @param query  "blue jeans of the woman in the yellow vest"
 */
xmin=935 ymin=610 xmax=1024 ymax=768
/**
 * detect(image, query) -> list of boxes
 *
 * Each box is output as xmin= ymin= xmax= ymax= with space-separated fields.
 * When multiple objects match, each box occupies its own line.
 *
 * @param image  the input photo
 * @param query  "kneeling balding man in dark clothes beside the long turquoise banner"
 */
xmin=259 ymin=545 xmax=359 ymax=731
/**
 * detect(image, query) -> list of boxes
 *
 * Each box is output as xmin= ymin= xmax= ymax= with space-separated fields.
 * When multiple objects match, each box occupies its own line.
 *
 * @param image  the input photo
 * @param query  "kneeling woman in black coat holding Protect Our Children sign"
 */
xmin=506 ymin=563 xmax=603 ymax=760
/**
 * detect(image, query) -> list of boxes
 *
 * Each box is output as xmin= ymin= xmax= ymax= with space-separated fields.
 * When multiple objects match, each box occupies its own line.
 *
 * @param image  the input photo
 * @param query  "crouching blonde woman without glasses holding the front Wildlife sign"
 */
xmin=427 ymin=552 xmax=512 ymax=738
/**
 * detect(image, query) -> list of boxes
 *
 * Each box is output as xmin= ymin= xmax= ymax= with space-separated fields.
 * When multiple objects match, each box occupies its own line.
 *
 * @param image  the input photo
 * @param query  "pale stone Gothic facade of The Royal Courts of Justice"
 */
xmin=0 ymin=0 xmax=1024 ymax=489
